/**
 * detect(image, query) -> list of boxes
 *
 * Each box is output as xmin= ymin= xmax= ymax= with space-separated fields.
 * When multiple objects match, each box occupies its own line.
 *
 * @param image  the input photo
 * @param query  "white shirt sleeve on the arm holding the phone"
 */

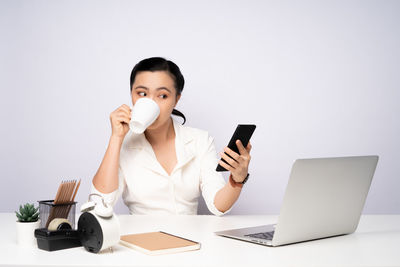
xmin=200 ymin=135 xmax=232 ymax=216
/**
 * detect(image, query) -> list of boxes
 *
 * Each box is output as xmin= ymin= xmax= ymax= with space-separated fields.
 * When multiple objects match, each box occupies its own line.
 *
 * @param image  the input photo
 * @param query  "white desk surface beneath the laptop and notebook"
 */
xmin=0 ymin=213 xmax=400 ymax=266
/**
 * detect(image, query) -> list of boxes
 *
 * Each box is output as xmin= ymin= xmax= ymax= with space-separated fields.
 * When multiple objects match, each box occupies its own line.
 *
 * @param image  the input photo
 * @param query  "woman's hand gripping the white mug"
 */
xmin=110 ymin=104 xmax=131 ymax=139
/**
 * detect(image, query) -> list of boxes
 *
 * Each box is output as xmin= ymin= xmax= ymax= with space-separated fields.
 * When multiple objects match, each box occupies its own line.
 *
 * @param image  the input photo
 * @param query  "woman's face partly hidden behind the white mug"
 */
xmin=132 ymin=71 xmax=180 ymax=129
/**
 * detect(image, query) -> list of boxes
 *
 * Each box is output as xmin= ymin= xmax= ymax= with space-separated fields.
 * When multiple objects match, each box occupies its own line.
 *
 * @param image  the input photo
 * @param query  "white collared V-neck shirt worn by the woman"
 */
xmin=91 ymin=120 xmax=229 ymax=215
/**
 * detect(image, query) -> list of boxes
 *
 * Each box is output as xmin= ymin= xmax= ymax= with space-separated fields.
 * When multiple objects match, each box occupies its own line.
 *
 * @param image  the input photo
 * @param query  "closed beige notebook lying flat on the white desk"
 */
xmin=120 ymin=232 xmax=201 ymax=255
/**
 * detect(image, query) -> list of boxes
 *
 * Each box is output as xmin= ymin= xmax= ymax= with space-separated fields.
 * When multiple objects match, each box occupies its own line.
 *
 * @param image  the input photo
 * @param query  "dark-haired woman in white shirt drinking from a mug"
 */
xmin=92 ymin=57 xmax=251 ymax=215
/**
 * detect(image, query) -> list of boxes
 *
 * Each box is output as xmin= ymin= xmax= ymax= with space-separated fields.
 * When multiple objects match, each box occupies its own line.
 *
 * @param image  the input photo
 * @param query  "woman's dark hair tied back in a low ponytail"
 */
xmin=130 ymin=57 xmax=186 ymax=124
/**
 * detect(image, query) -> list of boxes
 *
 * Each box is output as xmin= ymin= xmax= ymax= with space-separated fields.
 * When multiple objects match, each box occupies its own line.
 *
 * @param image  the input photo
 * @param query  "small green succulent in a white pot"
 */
xmin=15 ymin=203 xmax=40 ymax=246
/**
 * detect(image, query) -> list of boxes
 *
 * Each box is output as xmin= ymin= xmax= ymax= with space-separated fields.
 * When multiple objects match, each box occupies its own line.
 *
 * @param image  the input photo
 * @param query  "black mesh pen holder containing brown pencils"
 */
xmin=38 ymin=200 xmax=77 ymax=229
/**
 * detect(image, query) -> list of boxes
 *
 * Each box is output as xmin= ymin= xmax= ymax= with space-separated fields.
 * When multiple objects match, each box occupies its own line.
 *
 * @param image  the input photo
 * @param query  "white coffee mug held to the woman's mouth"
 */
xmin=129 ymin=97 xmax=160 ymax=134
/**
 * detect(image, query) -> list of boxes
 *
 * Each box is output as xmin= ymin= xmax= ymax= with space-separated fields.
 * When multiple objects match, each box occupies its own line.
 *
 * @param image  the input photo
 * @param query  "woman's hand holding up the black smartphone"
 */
xmin=219 ymin=140 xmax=251 ymax=183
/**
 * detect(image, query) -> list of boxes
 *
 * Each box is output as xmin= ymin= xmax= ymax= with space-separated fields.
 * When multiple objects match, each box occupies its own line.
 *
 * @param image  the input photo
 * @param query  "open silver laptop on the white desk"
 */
xmin=215 ymin=156 xmax=379 ymax=247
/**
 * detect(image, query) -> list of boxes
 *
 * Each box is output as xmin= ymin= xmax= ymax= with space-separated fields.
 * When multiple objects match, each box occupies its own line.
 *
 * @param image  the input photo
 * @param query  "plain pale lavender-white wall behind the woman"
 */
xmin=0 ymin=0 xmax=400 ymax=214
